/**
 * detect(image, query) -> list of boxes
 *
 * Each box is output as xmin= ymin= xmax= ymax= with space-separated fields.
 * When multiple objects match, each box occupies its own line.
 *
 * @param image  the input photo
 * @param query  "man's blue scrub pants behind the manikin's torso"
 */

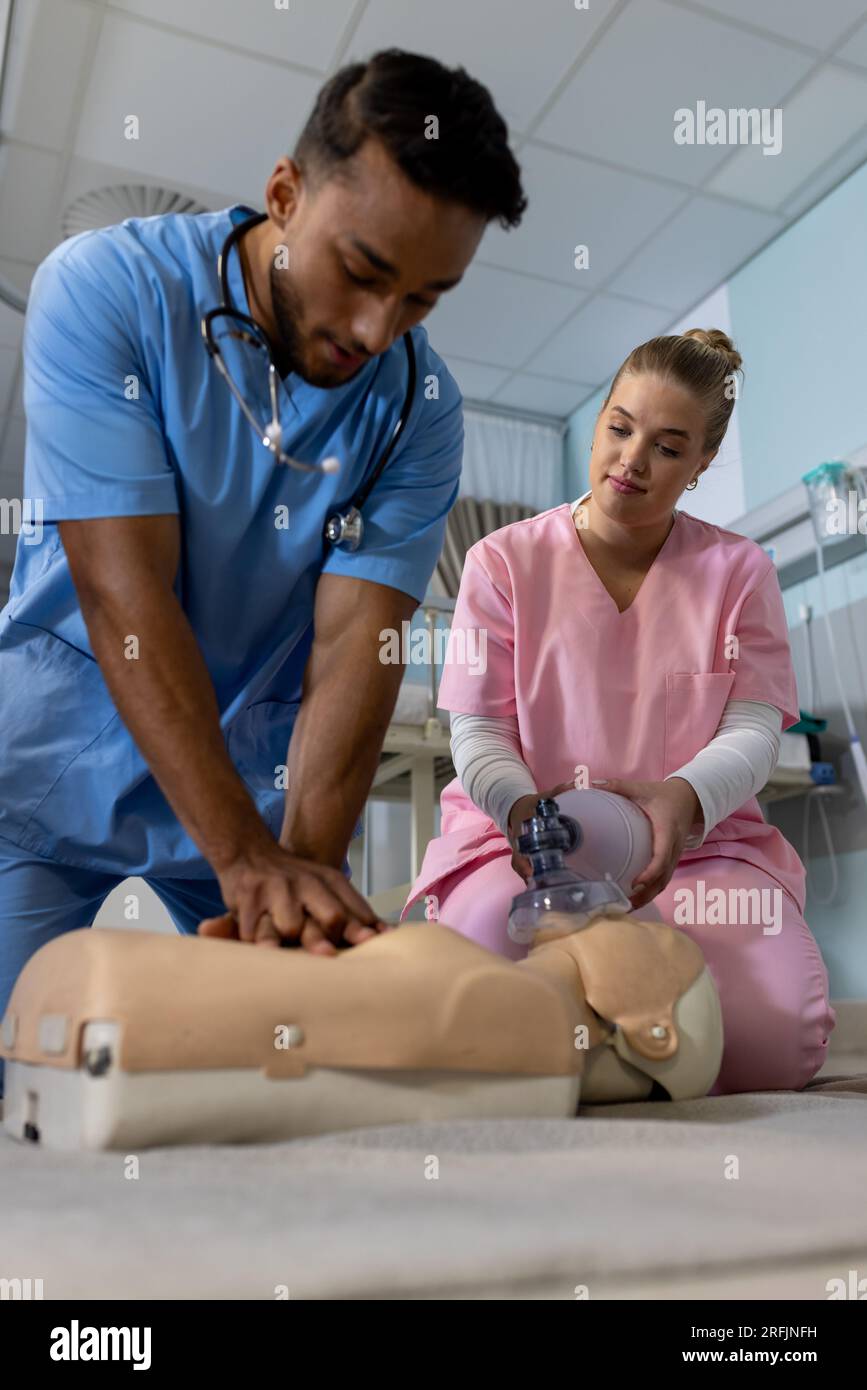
xmin=0 ymin=838 xmax=225 ymax=1095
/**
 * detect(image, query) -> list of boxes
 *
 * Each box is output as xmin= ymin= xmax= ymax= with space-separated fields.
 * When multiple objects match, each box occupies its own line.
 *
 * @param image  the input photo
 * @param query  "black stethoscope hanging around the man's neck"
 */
xmin=201 ymin=213 xmax=415 ymax=550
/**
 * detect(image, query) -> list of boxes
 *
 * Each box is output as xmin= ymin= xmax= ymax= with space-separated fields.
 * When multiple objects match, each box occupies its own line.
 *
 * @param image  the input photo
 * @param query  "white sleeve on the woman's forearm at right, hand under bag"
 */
xmin=666 ymin=699 xmax=782 ymax=849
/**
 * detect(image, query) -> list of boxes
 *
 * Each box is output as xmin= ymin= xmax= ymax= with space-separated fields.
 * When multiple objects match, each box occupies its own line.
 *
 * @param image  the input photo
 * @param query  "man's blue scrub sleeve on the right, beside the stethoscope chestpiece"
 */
xmin=322 ymin=354 xmax=464 ymax=603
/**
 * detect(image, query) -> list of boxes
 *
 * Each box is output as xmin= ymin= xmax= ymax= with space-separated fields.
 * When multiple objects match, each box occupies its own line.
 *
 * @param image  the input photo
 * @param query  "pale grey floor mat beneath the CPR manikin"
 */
xmin=0 ymin=1076 xmax=867 ymax=1300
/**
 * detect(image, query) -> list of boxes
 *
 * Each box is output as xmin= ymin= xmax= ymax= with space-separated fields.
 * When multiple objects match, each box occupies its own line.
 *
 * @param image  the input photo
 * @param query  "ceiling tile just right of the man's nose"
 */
xmin=425 ymin=264 xmax=586 ymax=369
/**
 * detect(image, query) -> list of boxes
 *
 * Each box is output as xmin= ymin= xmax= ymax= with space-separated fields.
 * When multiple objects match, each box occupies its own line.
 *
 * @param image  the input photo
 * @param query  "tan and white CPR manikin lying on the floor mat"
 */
xmin=0 ymin=794 xmax=723 ymax=1150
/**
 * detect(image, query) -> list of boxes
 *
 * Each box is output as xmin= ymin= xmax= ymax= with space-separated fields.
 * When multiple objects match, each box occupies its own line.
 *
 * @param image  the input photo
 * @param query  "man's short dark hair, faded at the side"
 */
xmin=292 ymin=49 xmax=527 ymax=228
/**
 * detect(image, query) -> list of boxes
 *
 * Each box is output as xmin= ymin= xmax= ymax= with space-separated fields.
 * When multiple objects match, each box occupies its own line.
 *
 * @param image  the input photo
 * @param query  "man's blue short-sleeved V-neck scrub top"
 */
xmin=0 ymin=206 xmax=464 ymax=878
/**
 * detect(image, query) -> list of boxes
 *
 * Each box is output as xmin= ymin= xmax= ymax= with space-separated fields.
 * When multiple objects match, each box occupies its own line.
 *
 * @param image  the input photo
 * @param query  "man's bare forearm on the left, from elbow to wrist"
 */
xmin=82 ymin=587 xmax=274 ymax=870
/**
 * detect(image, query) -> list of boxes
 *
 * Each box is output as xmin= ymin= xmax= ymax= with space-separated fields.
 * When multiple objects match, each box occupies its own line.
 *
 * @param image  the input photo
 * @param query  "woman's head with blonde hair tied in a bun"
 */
xmin=591 ymin=328 xmax=742 ymax=527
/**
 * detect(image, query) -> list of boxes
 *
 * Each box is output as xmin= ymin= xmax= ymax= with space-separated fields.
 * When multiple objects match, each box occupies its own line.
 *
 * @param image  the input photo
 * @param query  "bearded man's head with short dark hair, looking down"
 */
xmin=252 ymin=49 xmax=527 ymax=388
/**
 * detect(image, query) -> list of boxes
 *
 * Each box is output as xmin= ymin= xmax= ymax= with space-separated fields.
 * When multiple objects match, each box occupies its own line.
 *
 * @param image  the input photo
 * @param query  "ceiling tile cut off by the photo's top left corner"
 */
xmin=0 ymin=0 xmax=97 ymax=150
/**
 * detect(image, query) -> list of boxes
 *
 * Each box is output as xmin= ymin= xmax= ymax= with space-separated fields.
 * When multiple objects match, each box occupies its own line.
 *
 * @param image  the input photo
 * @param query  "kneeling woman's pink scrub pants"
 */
xmin=436 ymin=853 xmax=836 ymax=1095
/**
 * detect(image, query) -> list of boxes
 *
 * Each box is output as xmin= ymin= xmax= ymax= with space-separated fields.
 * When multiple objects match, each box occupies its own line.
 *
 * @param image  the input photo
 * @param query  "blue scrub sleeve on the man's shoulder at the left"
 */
xmin=24 ymin=232 xmax=179 ymax=521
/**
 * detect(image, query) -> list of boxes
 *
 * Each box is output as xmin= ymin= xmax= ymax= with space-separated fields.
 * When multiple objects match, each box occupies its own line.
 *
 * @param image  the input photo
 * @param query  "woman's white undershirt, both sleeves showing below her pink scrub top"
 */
xmin=450 ymin=699 xmax=782 ymax=849
